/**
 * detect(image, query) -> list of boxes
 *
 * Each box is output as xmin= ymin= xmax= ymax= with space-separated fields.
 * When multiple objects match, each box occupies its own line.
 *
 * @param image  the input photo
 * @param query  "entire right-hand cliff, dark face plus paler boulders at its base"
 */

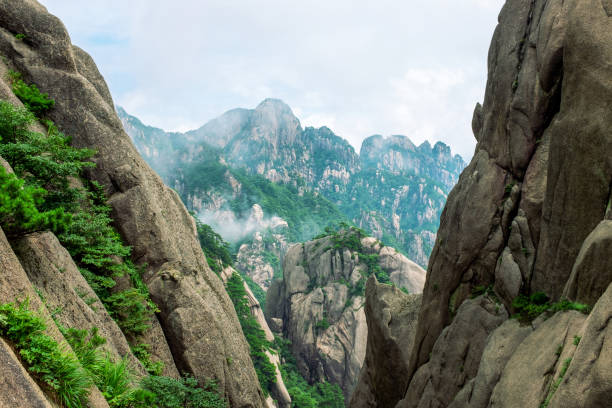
xmin=352 ymin=0 xmax=612 ymax=407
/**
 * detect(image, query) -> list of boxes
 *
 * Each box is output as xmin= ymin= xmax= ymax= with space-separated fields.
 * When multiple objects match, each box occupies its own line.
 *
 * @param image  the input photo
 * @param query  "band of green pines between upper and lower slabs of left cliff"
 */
xmin=0 ymin=100 xmax=157 ymax=334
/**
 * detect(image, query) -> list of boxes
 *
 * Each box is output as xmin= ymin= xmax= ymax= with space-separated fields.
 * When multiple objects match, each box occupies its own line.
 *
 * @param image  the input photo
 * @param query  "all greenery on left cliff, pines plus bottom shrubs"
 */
xmin=0 ymin=78 xmax=226 ymax=408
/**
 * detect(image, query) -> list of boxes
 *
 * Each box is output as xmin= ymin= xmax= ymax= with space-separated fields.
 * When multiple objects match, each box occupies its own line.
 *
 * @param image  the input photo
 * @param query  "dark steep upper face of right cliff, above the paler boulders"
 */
xmin=406 ymin=0 xmax=612 ymax=380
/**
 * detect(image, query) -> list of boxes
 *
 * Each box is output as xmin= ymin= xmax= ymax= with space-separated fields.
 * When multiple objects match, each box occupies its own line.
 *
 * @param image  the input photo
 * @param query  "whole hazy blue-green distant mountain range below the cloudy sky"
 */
xmin=118 ymin=99 xmax=465 ymax=287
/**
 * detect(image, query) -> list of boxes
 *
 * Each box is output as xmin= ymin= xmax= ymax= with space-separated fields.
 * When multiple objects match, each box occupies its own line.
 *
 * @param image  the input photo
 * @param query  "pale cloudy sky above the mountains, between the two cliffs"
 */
xmin=40 ymin=0 xmax=503 ymax=160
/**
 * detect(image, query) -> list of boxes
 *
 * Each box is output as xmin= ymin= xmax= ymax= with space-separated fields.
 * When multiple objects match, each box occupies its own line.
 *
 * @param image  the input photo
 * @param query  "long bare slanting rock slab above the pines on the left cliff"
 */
xmin=0 ymin=0 xmax=263 ymax=407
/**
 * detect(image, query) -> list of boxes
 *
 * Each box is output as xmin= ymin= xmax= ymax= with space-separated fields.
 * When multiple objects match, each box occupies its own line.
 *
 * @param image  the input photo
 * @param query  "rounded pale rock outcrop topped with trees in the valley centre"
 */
xmin=266 ymin=229 xmax=425 ymax=401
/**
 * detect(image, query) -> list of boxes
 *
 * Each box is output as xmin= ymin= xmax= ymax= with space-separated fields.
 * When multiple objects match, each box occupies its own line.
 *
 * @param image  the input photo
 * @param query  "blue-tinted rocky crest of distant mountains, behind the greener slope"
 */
xmin=117 ymin=98 xmax=465 ymax=266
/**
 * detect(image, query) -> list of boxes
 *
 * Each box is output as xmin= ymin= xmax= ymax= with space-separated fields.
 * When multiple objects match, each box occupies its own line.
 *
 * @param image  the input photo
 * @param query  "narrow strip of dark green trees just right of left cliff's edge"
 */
xmin=227 ymin=273 xmax=276 ymax=394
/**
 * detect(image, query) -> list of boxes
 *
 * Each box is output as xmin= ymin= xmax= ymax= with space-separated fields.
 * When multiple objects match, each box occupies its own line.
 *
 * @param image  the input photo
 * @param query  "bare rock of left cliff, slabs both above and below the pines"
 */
xmin=0 ymin=0 xmax=264 ymax=407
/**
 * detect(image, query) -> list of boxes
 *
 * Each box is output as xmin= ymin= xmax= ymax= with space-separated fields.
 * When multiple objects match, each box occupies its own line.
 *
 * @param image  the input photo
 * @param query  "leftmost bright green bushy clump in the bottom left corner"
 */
xmin=0 ymin=301 xmax=92 ymax=408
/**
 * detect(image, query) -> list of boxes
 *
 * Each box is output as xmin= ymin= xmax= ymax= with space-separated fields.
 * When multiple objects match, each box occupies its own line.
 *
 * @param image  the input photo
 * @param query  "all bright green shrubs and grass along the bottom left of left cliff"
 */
xmin=0 ymin=301 xmax=227 ymax=408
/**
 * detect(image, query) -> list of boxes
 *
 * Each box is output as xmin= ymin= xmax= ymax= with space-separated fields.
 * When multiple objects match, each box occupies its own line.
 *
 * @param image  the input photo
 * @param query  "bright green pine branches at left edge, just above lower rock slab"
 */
xmin=0 ymin=166 xmax=70 ymax=237
